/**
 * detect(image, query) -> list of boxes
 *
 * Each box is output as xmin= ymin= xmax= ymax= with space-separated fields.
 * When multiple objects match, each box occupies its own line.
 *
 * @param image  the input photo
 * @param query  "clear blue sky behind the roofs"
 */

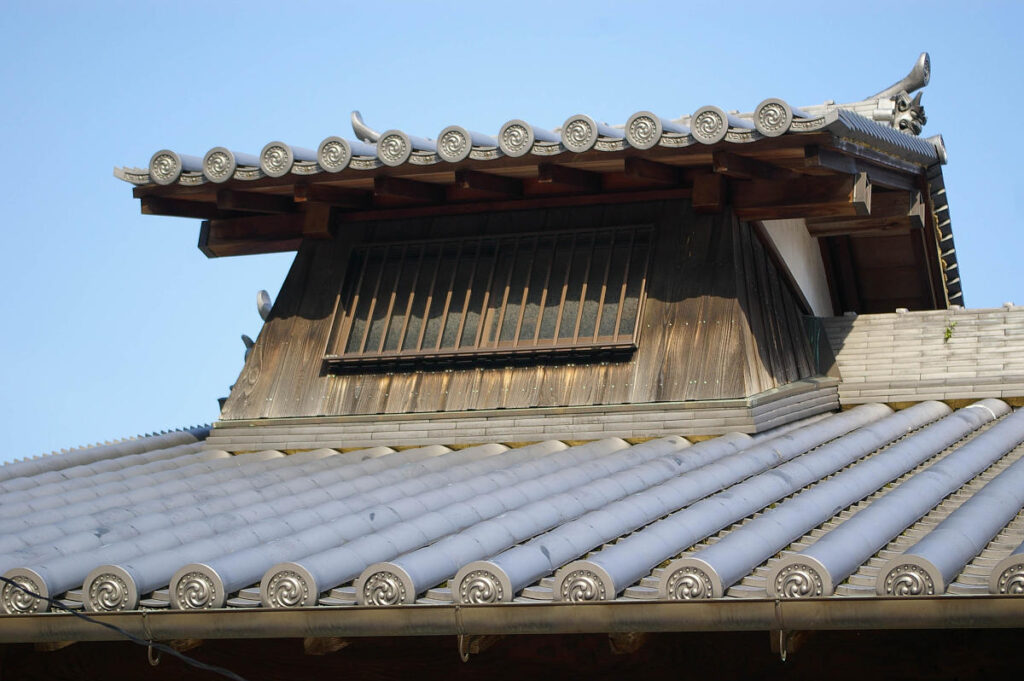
xmin=0 ymin=0 xmax=1024 ymax=461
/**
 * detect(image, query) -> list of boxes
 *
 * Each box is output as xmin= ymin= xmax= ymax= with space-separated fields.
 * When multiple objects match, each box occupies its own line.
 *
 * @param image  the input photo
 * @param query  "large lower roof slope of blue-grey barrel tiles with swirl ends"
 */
xmin=0 ymin=399 xmax=1024 ymax=614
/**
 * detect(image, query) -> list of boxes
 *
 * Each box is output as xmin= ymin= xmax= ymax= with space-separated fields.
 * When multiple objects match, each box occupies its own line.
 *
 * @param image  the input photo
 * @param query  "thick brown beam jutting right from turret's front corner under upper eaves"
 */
xmin=732 ymin=173 xmax=871 ymax=220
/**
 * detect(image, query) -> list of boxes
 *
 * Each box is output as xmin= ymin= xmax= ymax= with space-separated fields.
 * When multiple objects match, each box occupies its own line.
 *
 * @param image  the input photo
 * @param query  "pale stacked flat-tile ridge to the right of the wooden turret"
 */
xmin=823 ymin=303 xmax=1024 ymax=406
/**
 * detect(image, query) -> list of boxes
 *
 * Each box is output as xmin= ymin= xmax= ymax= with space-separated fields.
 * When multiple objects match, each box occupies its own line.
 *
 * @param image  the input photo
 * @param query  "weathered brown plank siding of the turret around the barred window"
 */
xmin=221 ymin=201 xmax=813 ymax=420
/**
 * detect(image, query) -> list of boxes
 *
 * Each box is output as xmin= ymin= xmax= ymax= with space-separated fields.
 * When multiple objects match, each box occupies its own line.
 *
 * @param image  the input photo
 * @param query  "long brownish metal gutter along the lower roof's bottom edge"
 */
xmin=0 ymin=595 xmax=1024 ymax=643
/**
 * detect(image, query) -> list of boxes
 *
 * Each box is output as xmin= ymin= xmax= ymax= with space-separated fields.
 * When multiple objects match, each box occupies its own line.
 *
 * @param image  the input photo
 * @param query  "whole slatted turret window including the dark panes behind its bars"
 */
xmin=326 ymin=226 xmax=650 ymax=367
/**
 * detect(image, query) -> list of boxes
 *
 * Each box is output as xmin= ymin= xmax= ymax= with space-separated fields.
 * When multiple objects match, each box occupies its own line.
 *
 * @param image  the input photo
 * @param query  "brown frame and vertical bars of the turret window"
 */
xmin=324 ymin=224 xmax=654 ymax=373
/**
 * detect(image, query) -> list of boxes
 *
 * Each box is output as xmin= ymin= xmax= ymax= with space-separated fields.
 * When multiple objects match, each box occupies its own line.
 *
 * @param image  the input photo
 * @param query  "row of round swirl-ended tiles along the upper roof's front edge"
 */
xmin=150 ymin=98 xmax=812 ymax=184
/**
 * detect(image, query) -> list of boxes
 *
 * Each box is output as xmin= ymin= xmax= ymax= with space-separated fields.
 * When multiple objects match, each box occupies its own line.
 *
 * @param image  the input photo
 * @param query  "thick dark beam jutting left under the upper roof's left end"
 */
xmin=199 ymin=213 xmax=305 ymax=258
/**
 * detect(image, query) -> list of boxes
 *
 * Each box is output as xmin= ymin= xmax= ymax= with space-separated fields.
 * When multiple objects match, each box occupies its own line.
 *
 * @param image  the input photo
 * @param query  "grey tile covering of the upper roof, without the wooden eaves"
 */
xmin=114 ymin=98 xmax=946 ymax=185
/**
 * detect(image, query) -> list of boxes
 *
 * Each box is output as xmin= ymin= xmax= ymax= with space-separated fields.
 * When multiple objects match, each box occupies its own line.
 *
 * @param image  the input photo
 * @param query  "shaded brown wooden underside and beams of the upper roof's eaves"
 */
xmin=133 ymin=131 xmax=948 ymax=312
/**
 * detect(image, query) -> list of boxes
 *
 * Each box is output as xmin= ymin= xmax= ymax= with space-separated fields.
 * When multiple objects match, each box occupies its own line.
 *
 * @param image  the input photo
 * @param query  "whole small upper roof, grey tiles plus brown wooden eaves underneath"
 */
xmin=115 ymin=53 xmax=964 ymax=312
